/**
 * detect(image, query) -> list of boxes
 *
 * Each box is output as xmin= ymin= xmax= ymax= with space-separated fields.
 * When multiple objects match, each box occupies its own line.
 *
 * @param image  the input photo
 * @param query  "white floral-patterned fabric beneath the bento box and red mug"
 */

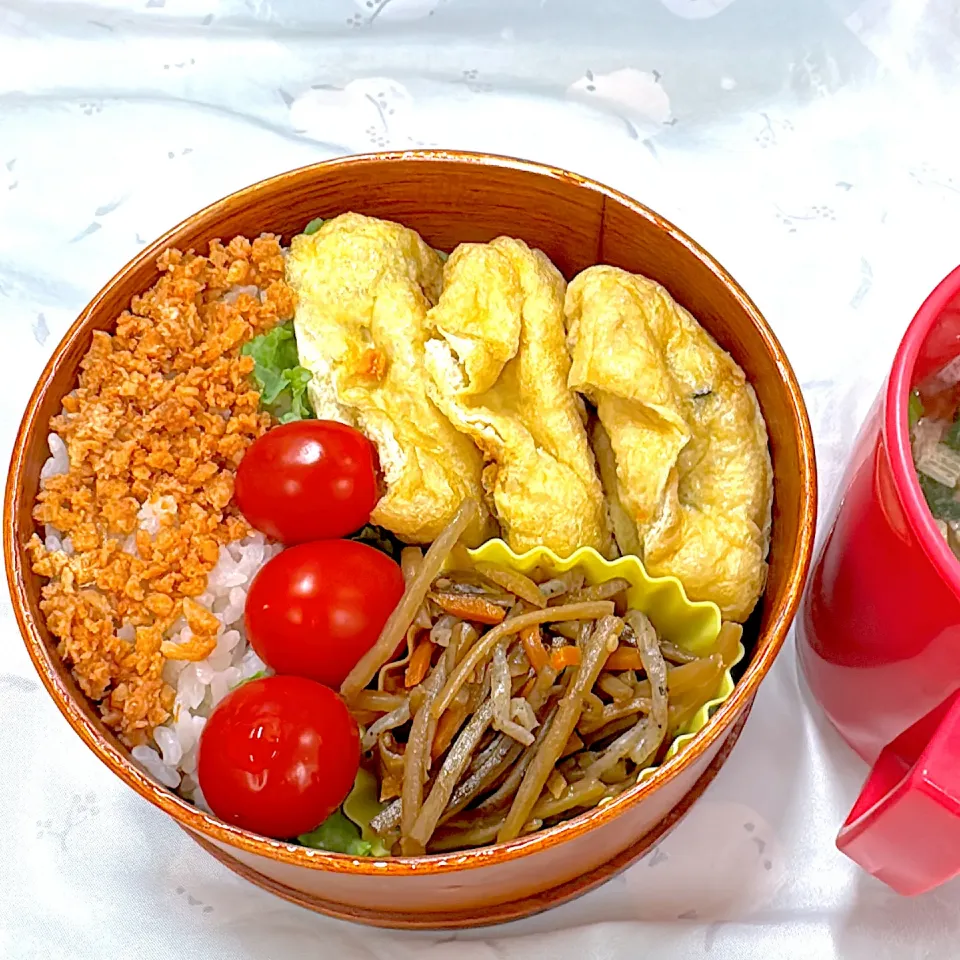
xmin=0 ymin=0 xmax=960 ymax=960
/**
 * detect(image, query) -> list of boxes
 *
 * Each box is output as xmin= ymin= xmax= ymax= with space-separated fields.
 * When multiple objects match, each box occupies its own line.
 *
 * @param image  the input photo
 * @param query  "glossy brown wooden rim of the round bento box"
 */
xmin=4 ymin=150 xmax=817 ymax=876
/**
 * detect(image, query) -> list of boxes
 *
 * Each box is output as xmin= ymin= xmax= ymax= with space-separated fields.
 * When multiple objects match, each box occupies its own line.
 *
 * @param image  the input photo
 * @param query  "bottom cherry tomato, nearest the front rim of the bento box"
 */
xmin=197 ymin=677 xmax=360 ymax=840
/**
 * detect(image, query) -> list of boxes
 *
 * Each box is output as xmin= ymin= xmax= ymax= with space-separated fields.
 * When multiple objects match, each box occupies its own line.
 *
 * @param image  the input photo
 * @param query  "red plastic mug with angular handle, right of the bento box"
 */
xmin=797 ymin=260 xmax=960 ymax=894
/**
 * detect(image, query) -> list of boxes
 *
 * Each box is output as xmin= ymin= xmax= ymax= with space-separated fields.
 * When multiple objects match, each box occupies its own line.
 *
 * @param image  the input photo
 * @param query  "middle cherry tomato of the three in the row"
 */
xmin=244 ymin=540 xmax=404 ymax=687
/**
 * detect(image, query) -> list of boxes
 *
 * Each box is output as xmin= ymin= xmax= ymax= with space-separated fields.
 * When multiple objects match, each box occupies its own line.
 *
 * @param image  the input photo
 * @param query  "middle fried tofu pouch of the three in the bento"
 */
xmin=426 ymin=237 xmax=611 ymax=556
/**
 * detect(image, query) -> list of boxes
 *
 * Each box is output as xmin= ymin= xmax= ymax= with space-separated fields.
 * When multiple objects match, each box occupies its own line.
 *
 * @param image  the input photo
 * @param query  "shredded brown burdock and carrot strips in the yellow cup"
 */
xmin=343 ymin=503 xmax=741 ymax=856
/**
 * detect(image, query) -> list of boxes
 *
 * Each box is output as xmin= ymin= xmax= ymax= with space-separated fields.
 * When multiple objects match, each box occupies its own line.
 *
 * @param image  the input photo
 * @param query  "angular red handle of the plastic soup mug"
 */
xmin=837 ymin=691 xmax=960 ymax=896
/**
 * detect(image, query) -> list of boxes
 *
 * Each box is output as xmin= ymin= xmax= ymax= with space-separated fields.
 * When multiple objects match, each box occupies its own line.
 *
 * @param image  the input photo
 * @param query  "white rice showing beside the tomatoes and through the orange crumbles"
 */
xmin=40 ymin=433 xmax=283 ymax=809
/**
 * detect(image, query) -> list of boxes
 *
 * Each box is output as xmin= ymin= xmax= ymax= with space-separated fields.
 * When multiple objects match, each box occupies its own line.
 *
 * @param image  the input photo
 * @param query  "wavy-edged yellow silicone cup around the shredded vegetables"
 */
xmin=456 ymin=540 xmax=744 ymax=781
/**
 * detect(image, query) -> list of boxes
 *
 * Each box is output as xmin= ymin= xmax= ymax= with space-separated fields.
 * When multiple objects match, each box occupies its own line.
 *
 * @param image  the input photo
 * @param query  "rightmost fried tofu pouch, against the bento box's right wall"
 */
xmin=566 ymin=266 xmax=773 ymax=621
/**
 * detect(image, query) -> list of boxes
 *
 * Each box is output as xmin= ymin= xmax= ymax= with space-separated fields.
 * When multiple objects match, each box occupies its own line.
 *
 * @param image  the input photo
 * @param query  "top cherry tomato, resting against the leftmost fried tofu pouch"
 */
xmin=234 ymin=420 xmax=377 ymax=544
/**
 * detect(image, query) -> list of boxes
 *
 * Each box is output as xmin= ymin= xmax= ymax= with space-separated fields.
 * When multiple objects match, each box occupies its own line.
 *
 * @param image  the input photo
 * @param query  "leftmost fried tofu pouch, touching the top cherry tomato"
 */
xmin=286 ymin=213 xmax=493 ymax=544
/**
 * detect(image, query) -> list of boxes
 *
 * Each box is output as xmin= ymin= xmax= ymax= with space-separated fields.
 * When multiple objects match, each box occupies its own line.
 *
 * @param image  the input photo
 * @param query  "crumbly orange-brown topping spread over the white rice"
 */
xmin=27 ymin=235 xmax=295 ymax=745
